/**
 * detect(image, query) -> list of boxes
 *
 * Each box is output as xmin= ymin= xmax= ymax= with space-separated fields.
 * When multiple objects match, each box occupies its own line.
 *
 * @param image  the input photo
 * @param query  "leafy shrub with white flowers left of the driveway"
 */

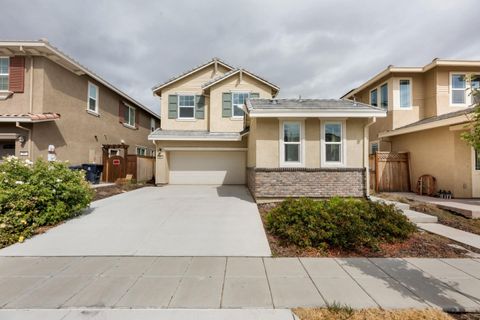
xmin=0 ymin=157 xmax=93 ymax=247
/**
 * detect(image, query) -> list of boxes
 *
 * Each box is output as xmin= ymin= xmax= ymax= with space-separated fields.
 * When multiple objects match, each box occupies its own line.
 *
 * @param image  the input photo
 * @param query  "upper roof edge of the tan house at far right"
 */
xmin=340 ymin=58 xmax=480 ymax=99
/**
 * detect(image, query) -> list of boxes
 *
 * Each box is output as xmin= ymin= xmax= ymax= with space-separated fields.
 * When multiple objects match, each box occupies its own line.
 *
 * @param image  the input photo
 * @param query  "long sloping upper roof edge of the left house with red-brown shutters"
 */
xmin=0 ymin=40 xmax=160 ymax=119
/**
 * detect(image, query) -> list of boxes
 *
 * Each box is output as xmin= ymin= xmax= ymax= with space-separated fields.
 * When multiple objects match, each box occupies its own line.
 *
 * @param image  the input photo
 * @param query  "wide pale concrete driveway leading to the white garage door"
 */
xmin=0 ymin=185 xmax=271 ymax=256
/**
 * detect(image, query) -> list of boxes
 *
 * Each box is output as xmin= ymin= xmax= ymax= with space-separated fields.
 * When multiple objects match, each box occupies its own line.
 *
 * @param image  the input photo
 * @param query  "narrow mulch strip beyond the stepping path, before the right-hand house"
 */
xmin=378 ymin=193 xmax=480 ymax=235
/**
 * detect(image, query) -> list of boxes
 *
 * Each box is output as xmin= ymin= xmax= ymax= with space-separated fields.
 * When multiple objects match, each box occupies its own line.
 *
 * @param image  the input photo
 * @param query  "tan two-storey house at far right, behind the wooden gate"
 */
xmin=342 ymin=59 xmax=480 ymax=198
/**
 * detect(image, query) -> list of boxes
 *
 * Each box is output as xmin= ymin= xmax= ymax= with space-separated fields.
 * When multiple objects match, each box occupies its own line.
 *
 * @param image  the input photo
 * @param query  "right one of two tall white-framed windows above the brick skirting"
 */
xmin=322 ymin=122 xmax=344 ymax=165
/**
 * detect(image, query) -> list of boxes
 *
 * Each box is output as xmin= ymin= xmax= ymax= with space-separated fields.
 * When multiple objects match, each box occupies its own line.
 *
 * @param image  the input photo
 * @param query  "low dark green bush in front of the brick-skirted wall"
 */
xmin=266 ymin=198 xmax=415 ymax=250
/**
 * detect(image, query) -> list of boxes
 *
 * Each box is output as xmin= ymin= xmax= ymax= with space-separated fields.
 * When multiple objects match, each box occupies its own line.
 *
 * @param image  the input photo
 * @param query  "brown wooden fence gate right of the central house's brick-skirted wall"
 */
xmin=370 ymin=151 xmax=410 ymax=192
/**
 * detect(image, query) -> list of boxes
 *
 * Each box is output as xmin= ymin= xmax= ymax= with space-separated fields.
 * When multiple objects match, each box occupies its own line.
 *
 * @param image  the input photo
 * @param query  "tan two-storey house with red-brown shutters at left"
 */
xmin=0 ymin=41 xmax=160 ymax=180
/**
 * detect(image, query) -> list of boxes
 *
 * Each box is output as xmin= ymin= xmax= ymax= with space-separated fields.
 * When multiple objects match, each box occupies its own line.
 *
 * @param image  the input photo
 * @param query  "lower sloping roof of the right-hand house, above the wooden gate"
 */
xmin=378 ymin=107 xmax=477 ymax=138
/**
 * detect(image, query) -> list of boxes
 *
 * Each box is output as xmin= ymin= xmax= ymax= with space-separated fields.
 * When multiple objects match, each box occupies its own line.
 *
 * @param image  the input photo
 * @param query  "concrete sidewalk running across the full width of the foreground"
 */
xmin=0 ymin=257 xmax=480 ymax=312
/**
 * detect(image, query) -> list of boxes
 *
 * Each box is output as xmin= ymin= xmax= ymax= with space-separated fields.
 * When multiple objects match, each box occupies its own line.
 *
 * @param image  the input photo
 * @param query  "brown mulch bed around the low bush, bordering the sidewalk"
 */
xmin=258 ymin=203 xmax=480 ymax=258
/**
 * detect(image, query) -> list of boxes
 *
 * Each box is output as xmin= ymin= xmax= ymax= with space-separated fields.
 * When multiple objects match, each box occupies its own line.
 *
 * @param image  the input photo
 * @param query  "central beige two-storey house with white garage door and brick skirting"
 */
xmin=149 ymin=59 xmax=386 ymax=200
